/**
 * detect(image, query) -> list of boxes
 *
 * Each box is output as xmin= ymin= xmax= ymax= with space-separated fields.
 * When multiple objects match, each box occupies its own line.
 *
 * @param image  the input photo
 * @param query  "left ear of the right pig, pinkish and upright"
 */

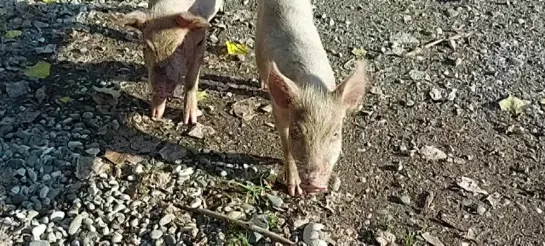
xmin=267 ymin=62 xmax=299 ymax=109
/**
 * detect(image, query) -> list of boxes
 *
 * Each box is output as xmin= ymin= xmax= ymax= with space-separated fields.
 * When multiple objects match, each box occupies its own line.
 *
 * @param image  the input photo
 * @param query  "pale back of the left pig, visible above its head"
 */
xmin=149 ymin=0 xmax=223 ymax=21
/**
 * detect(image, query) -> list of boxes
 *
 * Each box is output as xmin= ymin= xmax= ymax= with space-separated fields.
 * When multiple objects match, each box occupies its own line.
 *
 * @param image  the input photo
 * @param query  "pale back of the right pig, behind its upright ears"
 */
xmin=256 ymin=0 xmax=335 ymax=90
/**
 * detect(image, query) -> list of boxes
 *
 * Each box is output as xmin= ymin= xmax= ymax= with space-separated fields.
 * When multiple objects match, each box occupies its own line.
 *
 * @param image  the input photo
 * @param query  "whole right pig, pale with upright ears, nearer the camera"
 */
xmin=255 ymin=0 xmax=367 ymax=196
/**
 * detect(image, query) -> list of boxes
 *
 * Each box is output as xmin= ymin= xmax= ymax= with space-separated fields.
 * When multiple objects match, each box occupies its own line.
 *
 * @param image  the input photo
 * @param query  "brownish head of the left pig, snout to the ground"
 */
xmin=124 ymin=11 xmax=208 ymax=118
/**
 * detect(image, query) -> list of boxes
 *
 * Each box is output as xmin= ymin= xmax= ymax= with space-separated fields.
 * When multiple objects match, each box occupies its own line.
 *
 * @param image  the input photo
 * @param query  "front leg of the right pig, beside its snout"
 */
xmin=274 ymin=112 xmax=303 ymax=196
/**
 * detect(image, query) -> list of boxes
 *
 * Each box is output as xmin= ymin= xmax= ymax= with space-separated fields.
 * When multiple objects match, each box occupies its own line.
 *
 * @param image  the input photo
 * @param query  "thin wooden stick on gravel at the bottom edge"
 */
xmin=174 ymin=205 xmax=295 ymax=245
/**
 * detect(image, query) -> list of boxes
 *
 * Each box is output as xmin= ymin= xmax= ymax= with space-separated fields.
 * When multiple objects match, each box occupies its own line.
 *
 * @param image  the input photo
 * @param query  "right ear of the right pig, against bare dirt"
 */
xmin=335 ymin=60 xmax=367 ymax=111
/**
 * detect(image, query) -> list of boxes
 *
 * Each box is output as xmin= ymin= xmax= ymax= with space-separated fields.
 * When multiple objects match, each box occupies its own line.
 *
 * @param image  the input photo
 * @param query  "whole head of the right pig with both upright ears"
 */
xmin=268 ymin=61 xmax=367 ymax=193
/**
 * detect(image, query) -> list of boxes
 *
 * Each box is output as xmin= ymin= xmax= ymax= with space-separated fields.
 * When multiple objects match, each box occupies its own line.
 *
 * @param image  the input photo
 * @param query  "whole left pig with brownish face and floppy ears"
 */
xmin=123 ymin=0 xmax=223 ymax=124
